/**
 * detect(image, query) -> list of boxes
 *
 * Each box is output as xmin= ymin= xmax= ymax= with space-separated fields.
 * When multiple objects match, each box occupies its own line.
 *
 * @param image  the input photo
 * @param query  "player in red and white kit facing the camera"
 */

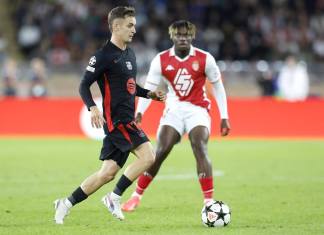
xmin=122 ymin=20 xmax=230 ymax=211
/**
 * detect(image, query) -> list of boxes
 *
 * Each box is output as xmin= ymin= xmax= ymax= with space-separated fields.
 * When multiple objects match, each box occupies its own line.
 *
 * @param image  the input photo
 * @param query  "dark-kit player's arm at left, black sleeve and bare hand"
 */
xmin=79 ymin=52 xmax=105 ymax=128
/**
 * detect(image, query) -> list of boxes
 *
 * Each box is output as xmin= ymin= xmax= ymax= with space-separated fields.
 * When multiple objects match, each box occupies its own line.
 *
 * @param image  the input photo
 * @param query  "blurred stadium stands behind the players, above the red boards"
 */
xmin=0 ymin=0 xmax=324 ymax=97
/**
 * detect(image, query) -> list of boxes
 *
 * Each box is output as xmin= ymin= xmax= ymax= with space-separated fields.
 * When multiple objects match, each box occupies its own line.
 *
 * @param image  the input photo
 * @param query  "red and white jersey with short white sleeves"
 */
xmin=146 ymin=46 xmax=221 ymax=109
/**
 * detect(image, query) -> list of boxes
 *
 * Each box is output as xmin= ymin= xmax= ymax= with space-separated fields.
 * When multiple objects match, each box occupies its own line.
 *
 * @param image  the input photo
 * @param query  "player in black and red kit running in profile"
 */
xmin=55 ymin=6 xmax=165 ymax=224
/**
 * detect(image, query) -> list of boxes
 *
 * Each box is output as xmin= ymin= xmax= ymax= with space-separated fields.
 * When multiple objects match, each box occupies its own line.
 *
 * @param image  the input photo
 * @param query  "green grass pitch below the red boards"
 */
xmin=0 ymin=138 xmax=324 ymax=235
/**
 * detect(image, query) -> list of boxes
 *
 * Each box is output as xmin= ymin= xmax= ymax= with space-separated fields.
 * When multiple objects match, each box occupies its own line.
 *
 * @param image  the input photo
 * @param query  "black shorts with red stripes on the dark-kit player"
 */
xmin=99 ymin=122 xmax=149 ymax=168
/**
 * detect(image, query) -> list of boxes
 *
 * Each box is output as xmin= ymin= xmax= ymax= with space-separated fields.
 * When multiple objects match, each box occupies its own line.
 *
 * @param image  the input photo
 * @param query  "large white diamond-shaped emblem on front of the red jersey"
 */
xmin=173 ymin=69 xmax=194 ymax=96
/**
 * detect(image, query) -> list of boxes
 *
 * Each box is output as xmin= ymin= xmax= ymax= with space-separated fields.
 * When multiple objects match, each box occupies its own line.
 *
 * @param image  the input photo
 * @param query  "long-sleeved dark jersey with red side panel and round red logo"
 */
xmin=79 ymin=41 xmax=149 ymax=134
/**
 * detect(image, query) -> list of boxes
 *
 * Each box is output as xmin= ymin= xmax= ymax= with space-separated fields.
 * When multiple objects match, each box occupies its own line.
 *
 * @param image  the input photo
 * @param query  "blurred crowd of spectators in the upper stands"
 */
xmin=13 ymin=0 xmax=324 ymax=67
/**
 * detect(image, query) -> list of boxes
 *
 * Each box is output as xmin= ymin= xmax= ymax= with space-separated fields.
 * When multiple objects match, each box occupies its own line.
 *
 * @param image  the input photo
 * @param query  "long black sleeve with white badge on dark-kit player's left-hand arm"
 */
xmin=79 ymin=52 xmax=106 ymax=110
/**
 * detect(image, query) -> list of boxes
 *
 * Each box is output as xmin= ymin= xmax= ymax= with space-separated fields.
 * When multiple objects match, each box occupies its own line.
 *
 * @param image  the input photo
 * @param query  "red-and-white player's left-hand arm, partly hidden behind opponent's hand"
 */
xmin=135 ymin=54 xmax=162 ymax=123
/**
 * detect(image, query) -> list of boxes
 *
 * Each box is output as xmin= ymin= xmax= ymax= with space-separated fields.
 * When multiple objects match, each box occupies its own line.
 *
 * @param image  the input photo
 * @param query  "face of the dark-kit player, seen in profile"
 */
xmin=116 ymin=16 xmax=136 ymax=43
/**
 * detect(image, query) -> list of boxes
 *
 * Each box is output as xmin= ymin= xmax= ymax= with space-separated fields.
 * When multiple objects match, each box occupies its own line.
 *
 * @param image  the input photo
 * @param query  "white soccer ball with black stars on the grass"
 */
xmin=201 ymin=201 xmax=231 ymax=227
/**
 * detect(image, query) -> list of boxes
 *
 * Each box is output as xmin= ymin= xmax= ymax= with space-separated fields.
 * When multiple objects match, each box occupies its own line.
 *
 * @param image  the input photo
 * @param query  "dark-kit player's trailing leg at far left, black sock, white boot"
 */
xmin=55 ymin=160 xmax=120 ymax=224
